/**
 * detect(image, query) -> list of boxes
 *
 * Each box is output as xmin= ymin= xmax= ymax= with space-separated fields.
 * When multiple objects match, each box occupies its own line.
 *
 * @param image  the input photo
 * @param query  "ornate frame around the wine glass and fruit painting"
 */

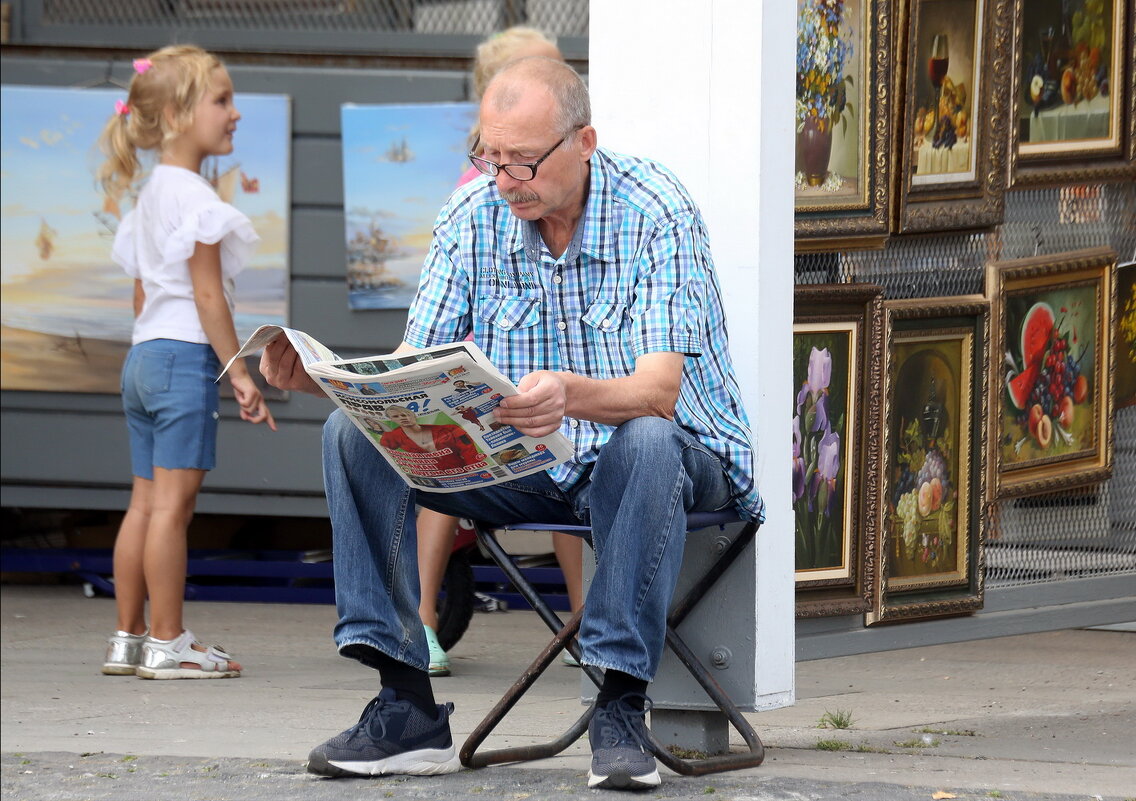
xmin=893 ymin=0 xmax=1012 ymax=233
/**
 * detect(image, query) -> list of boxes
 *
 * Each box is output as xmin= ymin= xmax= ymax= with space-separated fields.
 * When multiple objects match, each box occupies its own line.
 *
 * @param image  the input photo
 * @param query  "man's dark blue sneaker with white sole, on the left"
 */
xmin=308 ymin=690 xmax=461 ymax=777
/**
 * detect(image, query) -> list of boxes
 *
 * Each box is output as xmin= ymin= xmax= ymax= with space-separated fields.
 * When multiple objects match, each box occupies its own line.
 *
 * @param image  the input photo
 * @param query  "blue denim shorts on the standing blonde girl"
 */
xmin=123 ymin=340 xmax=220 ymax=479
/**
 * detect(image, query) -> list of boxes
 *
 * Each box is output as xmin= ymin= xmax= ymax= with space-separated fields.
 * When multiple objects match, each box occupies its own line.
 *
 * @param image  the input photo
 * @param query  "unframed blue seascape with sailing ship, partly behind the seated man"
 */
xmin=342 ymin=103 xmax=477 ymax=309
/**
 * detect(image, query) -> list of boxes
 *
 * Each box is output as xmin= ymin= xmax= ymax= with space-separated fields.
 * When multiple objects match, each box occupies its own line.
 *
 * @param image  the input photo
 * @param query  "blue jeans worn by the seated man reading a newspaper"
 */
xmin=324 ymin=410 xmax=733 ymax=681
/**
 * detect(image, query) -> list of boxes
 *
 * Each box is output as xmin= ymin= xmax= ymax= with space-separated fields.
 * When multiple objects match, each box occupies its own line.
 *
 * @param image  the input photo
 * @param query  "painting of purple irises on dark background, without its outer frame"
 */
xmin=793 ymin=324 xmax=857 ymax=581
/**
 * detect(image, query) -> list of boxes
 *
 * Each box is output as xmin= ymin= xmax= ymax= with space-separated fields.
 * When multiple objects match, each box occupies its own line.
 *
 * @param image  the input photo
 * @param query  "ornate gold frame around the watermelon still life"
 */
xmin=986 ymin=248 xmax=1117 ymax=499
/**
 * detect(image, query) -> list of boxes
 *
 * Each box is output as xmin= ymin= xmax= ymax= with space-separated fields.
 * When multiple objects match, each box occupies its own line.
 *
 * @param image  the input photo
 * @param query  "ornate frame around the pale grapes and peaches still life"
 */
xmin=864 ymin=295 xmax=989 ymax=626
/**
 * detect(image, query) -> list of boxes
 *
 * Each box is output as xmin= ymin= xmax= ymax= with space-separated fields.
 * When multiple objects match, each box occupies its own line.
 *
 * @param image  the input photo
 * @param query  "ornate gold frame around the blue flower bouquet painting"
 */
xmin=794 ymin=0 xmax=895 ymax=252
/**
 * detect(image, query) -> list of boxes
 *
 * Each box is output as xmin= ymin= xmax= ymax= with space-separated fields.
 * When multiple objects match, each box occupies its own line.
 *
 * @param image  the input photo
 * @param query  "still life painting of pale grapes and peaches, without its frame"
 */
xmin=887 ymin=335 xmax=972 ymax=589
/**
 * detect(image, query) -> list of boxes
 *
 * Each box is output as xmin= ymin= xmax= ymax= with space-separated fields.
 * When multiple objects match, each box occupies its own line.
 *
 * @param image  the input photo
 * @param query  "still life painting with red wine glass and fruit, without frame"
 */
xmin=910 ymin=0 xmax=984 ymax=184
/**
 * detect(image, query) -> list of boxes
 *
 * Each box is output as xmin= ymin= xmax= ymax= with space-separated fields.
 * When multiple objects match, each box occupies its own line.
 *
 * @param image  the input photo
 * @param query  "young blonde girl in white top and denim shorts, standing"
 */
xmin=99 ymin=45 xmax=276 ymax=678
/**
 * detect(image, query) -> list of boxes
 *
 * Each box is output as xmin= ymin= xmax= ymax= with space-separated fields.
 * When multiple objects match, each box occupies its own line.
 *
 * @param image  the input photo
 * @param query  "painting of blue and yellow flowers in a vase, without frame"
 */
xmin=795 ymin=0 xmax=870 ymax=201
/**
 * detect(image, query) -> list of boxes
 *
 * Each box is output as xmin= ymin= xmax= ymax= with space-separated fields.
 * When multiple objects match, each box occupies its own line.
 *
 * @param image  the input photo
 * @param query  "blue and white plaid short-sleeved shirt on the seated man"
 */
xmin=406 ymin=149 xmax=765 ymax=520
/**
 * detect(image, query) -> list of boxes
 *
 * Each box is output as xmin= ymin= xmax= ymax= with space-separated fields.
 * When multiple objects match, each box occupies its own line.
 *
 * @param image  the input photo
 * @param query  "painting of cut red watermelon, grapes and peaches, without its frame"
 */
xmin=999 ymin=283 xmax=1099 ymax=469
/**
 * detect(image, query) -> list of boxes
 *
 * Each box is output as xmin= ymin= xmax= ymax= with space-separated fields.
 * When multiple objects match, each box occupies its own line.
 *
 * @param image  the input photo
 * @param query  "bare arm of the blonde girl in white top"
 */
xmin=189 ymin=242 xmax=276 ymax=431
